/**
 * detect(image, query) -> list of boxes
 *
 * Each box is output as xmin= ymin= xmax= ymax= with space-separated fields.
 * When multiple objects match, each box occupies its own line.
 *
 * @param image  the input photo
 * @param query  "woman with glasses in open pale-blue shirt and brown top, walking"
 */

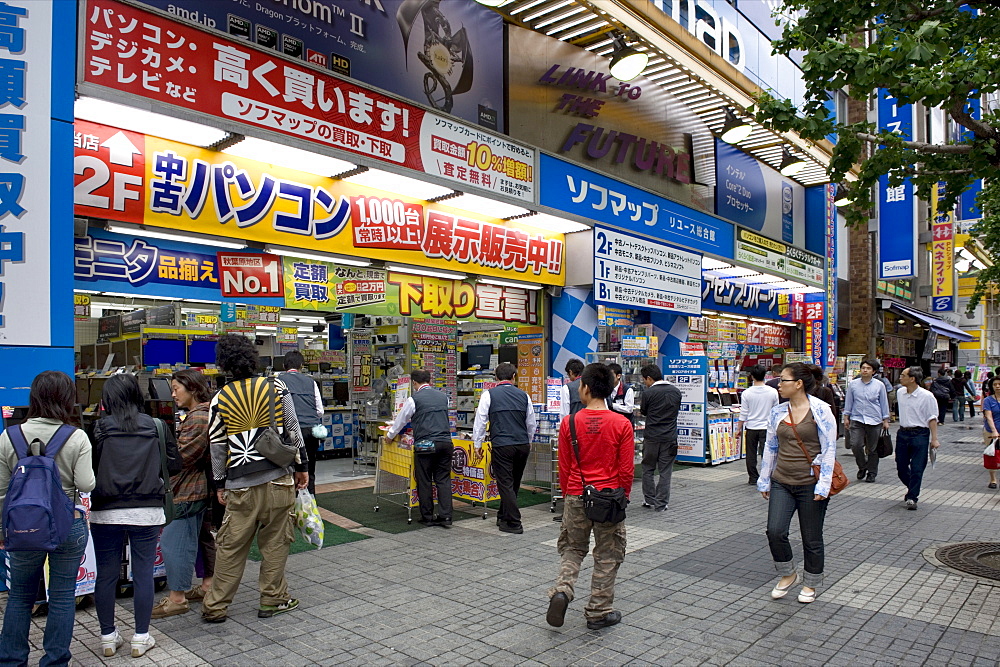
xmin=757 ymin=363 xmax=836 ymax=603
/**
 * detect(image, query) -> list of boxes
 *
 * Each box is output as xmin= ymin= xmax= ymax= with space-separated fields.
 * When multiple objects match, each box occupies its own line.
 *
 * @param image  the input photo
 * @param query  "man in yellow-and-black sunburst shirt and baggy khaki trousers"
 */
xmin=201 ymin=334 xmax=309 ymax=623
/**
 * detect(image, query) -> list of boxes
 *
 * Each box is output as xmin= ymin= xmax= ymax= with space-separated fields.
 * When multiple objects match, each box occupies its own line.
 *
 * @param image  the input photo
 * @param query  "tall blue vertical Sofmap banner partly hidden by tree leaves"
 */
xmin=878 ymin=89 xmax=917 ymax=280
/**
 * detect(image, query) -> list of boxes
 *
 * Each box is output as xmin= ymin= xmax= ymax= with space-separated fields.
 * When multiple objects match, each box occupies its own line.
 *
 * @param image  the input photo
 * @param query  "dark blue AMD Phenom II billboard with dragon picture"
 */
xmin=138 ymin=0 xmax=506 ymax=131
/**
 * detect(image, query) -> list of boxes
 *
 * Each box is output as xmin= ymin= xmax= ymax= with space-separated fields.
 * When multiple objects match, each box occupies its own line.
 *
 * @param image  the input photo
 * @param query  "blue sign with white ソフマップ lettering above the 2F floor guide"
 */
xmin=539 ymin=154 xmax=736 ymax=259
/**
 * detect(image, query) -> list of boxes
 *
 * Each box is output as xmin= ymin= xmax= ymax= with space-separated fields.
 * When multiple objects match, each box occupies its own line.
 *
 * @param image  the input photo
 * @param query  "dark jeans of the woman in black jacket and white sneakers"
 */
xmin=90 ymin=523 xmax=162 ymax=635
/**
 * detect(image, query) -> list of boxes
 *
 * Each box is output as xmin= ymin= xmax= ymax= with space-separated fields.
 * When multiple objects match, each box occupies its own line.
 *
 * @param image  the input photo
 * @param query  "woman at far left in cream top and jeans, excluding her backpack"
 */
xmin=0 ymin=371 xmax=94 ymax=667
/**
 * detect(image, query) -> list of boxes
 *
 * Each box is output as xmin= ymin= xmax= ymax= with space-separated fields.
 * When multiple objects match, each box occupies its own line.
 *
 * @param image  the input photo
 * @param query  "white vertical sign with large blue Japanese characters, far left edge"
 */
xmin=0 ymin=0 xmax=75 ymax=350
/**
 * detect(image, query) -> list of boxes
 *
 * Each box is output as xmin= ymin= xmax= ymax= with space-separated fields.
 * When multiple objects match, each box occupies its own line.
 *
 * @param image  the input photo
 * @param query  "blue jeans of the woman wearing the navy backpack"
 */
xmin=0 ymin=518 xmax=87 ymax=667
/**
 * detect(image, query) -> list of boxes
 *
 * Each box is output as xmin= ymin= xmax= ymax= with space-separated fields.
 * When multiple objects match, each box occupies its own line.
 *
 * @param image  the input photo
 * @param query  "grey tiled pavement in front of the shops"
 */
xmin=7 ymin=419 xmax=1000 ymax=666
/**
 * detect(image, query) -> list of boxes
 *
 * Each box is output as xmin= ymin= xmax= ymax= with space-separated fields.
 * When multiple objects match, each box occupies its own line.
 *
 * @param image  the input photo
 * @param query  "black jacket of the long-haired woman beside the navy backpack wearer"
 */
xmin=91 ymin=414 xmax=181 ymax=510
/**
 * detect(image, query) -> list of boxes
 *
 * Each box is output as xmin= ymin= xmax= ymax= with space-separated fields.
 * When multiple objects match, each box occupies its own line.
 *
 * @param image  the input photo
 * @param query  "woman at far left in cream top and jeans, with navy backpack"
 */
xmin=0 ymin=371 xmax=94 ymax=667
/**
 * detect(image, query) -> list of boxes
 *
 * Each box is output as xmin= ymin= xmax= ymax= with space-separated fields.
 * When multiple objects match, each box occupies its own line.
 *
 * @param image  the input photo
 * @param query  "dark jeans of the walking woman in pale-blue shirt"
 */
xmin=767 ymin=480 xmax=830 ymax=588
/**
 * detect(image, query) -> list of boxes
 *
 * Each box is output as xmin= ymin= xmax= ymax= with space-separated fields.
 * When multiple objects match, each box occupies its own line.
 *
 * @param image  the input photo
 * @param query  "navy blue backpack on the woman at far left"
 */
xmin=3 ymin=424 xmax=76 ymax=552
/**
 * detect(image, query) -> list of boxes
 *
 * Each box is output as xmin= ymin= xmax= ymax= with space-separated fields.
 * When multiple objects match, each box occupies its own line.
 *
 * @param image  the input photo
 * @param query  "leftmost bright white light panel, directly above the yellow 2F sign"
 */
xmin=73 ymin=97 xmax=229 ymax=148
